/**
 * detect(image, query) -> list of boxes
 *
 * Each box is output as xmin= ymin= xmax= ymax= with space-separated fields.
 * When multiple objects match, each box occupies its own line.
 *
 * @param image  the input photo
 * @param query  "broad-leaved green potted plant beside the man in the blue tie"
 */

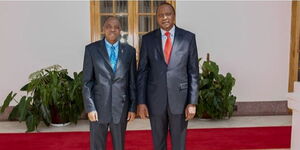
xmin=0 ymin=65 xmax=83 ymax=132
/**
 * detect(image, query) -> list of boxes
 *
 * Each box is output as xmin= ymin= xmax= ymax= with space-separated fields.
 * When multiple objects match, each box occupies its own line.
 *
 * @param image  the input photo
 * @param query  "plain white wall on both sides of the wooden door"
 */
xmin=0 ymin=1 xmax=291 ymax=105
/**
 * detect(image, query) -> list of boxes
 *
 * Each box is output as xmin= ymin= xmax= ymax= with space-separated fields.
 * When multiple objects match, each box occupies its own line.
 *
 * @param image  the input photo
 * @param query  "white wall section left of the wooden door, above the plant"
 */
xmin=0 ymin=1 xmax=90 ymax=105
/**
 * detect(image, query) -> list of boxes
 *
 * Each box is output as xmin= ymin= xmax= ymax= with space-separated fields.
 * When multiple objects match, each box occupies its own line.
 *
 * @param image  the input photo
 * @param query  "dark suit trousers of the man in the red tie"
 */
xmin=150 ymin=106 xmax=188 ymax=150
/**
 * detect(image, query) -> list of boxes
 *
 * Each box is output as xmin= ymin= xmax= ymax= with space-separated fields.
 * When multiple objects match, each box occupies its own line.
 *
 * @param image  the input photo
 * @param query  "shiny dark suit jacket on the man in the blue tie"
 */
xmin=83 ymin=40 xmax=136 ymax=123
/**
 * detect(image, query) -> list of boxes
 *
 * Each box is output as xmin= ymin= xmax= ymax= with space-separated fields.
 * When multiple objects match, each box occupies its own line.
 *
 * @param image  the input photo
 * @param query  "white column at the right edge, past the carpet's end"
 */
xmin=287 ymin=82 xmax=300 ymax=150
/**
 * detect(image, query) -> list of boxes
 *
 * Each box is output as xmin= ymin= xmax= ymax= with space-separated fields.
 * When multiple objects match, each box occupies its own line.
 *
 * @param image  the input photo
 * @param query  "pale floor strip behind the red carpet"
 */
xmin=0 ymin=115 xmax=292 ymax=150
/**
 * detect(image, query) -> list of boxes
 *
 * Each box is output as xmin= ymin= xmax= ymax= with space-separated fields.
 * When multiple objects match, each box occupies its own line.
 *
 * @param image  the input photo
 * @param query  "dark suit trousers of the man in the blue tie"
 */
xmin=90 ymin=103 xmax=128 ymax=150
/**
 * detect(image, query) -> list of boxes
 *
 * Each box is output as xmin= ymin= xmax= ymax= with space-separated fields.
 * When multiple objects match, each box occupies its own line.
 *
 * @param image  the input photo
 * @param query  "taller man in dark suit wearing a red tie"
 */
xmin=137 ymin=3 xmax=199 ymax=150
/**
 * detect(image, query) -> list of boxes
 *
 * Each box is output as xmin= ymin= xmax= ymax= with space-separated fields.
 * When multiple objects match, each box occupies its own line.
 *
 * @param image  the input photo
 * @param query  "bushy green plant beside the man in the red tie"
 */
xmin=197 ymin=54 xmax=236 ymax=119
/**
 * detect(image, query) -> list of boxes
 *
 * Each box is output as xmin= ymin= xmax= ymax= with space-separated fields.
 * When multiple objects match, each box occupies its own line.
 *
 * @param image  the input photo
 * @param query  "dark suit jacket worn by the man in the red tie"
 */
xmin=137 ymin=27 xmax=199 ymax=115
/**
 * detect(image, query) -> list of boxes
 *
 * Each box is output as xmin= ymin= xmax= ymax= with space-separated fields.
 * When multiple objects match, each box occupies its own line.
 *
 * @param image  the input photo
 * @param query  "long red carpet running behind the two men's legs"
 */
xmin=0 ymin=126 xmax=291 ymax=150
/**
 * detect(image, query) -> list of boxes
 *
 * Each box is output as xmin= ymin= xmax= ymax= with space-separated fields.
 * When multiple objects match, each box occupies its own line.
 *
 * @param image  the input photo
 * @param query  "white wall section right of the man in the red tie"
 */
xmin=176 ymin=1 xmax=291 ymax=101
